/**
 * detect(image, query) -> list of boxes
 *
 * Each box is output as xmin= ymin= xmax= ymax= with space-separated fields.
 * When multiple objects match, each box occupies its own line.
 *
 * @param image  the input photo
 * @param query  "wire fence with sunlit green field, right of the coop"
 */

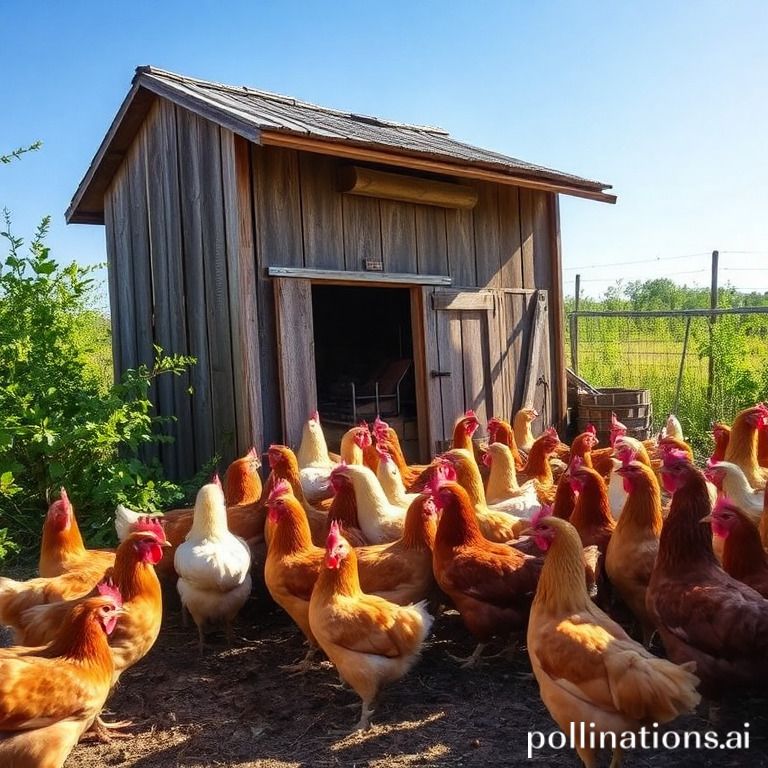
xmin=567 ymin=307 xmax=768 ymax=455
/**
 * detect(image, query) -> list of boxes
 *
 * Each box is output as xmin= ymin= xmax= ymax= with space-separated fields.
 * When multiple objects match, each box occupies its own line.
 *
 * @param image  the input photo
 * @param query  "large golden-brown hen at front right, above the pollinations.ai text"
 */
xmin=527 ymin=517 xmax=700 ymax=768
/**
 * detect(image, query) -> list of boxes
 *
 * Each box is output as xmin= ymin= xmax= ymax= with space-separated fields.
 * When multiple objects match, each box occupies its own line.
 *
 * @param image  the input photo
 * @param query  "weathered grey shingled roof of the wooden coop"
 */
xmin=66 ymin=67 xmax=616 ymax=223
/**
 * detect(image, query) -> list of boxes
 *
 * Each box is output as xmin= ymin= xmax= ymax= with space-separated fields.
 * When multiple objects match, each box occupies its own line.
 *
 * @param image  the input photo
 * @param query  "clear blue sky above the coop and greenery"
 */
xmin=0 ymin=0 xmax=768 ymax=294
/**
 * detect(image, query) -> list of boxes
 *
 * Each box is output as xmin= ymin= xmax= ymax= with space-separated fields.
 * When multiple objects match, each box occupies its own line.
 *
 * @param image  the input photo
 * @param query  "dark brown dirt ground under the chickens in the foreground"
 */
xmin=51 ymin=584 xmax=768 ymax=768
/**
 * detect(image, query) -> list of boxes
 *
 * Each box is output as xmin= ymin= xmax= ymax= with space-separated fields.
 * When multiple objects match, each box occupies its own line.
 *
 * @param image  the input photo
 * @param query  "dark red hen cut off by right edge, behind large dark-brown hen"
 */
xmin=703 ymin=496 xmax=768 ymax=597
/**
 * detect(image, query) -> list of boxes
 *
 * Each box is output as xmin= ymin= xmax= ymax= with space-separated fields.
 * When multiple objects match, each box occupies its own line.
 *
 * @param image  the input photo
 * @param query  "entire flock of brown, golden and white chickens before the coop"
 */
xmin=0 ymin=404 xmax=768 ymax=768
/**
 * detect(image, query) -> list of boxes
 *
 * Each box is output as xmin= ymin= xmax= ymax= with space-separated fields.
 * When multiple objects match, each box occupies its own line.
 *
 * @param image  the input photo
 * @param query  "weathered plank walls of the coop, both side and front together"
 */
xmin=105 ymin=99 xmax=564 ymax=477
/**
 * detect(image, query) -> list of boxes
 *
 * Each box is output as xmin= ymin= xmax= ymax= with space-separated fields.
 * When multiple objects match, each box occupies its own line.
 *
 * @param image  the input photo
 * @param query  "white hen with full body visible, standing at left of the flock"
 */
xmin=173 ymin=477 xmax=251 ymax=653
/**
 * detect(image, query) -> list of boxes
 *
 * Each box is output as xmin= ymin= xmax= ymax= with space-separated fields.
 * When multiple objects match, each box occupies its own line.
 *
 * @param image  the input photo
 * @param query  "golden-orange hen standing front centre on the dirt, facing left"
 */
xmin=309 ymin=526 xmax=433 ymax=729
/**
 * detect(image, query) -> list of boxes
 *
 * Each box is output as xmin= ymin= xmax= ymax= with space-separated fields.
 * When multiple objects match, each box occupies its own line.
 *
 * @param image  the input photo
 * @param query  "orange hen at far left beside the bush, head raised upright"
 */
xmin=38 ymin=488 xmax=115 ymax=578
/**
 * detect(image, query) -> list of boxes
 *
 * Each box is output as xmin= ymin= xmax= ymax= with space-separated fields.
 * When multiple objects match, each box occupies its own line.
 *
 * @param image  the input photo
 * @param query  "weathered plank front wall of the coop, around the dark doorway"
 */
xmin=251 ymin=146 xmax=561 ymax=442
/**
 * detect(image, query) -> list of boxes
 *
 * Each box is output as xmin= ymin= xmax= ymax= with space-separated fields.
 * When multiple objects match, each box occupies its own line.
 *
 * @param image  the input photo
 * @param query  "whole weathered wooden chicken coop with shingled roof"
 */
xmin=66 ymin=67 xmax=615 ymax=477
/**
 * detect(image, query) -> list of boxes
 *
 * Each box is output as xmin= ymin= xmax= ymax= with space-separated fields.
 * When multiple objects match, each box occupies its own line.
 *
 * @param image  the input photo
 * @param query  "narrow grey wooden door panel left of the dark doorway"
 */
xmin=274 ymin=277 xmax=317 ymax=450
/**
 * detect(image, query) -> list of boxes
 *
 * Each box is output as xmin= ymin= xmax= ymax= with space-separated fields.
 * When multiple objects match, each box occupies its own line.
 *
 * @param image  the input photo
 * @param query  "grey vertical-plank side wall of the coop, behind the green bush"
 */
xmin=105 ymin=100 xmax=263 ymax=478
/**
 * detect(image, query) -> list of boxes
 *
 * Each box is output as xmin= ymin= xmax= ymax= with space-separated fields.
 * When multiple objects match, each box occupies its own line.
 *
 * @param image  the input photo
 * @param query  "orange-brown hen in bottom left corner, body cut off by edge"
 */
xmin=0 ymin=590 xmax=122 ymax=768
